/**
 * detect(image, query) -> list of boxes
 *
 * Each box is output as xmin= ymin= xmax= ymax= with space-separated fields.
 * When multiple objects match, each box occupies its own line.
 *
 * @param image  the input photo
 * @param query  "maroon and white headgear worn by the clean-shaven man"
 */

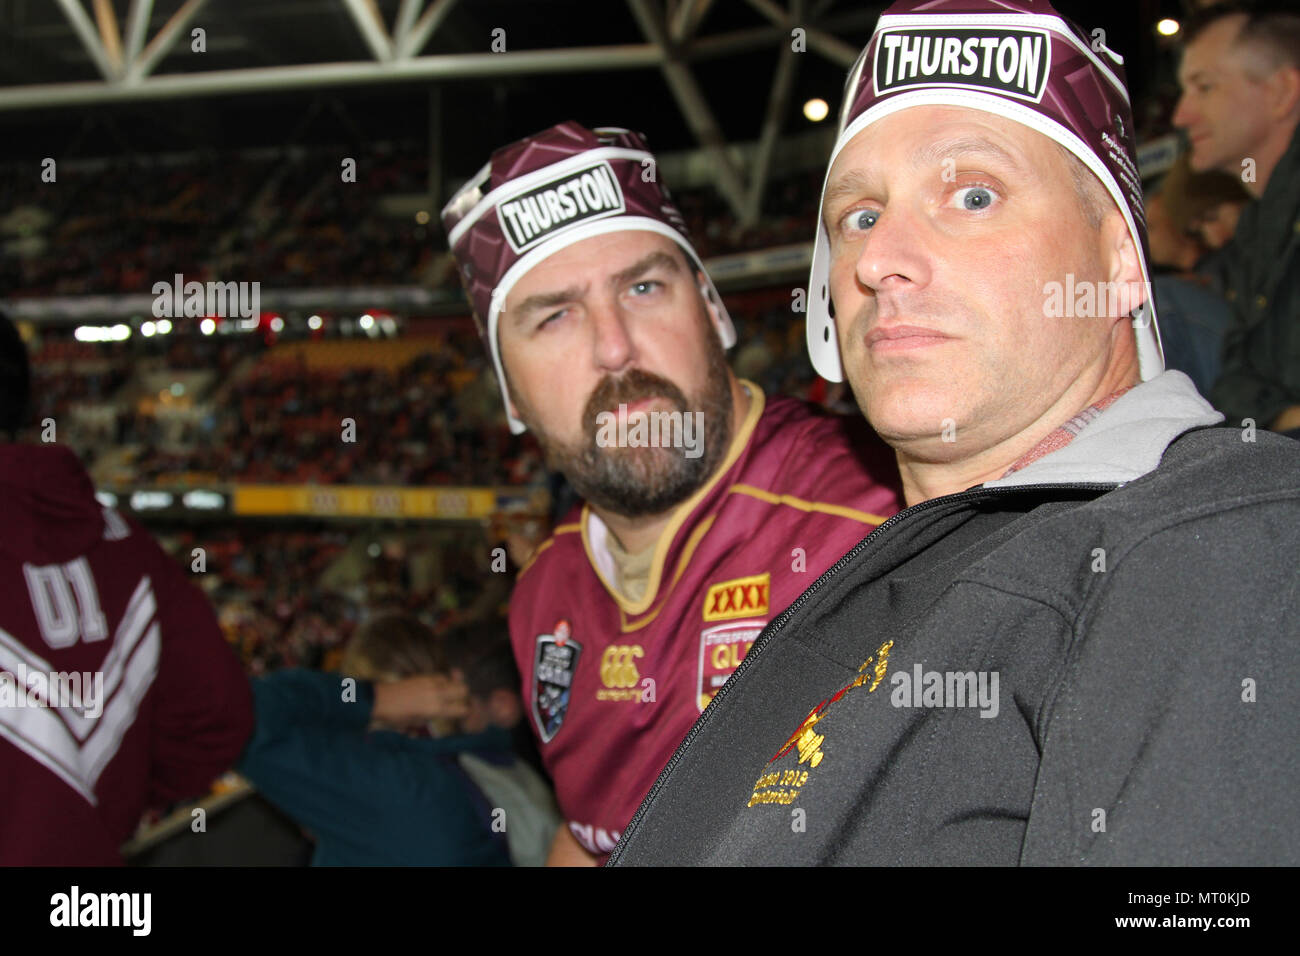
xmin=807 ymin=0 xmax=1165 ymax=381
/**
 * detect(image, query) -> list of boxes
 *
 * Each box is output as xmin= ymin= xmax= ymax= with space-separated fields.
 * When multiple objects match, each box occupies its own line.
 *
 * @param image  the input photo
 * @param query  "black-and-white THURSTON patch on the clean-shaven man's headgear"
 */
xmin=874 ymin=26 xmax=1052 ymax=103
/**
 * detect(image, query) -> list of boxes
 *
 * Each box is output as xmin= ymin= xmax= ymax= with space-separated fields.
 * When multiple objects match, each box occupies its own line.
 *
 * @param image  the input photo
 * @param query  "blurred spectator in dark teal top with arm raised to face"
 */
xmin=238 ymin=614 xmax=550 ymax=866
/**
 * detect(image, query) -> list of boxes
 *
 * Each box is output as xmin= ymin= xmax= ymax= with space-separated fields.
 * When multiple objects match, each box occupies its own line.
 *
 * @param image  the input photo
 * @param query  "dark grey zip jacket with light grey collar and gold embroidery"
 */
xmin=610 ymin=372 xmax=1300 ymax=865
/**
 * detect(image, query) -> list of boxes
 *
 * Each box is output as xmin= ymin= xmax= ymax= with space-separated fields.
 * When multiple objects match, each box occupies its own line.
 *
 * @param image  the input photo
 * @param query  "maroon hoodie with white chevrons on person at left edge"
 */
xmin=0 ymin=444 xmax=252 ymax=865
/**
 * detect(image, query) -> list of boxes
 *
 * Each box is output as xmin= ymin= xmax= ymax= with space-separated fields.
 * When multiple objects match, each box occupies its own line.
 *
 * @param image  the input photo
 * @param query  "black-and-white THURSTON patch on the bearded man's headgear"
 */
xmin=497 ymin=163 xmax=628 ymax=254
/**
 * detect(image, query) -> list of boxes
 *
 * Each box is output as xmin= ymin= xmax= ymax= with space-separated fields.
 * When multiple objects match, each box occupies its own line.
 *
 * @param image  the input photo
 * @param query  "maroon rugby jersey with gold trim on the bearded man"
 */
xmin=510 ymin=382 xmax=900 ymax=861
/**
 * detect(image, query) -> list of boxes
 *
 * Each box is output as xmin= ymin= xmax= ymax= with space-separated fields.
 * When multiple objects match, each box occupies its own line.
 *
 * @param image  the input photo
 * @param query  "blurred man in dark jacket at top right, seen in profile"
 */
xmin=1174 ymin=3 xmax=1300 ymax=436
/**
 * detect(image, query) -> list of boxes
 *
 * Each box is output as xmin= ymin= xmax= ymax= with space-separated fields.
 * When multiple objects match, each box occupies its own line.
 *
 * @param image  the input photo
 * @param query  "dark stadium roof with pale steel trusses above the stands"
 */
xmin=0 ymin=0 xmax=1162 ymax=219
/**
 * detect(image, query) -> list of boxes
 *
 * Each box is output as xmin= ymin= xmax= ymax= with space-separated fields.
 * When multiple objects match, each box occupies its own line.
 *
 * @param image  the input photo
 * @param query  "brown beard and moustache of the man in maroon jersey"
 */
xmin=528 ymin=330 xmax=733 ymax=518
